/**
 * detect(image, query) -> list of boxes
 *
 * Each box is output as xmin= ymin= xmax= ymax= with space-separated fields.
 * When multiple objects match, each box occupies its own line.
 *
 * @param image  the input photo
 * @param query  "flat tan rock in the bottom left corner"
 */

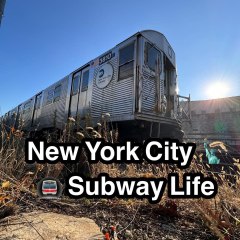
xmin=0 ymin=211 xmax=102 ymax=240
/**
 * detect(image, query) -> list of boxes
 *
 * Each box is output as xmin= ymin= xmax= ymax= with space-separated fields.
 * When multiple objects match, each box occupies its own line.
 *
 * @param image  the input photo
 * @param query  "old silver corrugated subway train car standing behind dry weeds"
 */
xmin=2 ymin=30 xmax=183 ymax=139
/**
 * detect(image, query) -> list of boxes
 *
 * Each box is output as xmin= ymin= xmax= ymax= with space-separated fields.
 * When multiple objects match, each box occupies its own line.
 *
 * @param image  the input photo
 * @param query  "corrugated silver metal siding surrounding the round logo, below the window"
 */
xmin=91 ymin=57 xmax=134 ymax=118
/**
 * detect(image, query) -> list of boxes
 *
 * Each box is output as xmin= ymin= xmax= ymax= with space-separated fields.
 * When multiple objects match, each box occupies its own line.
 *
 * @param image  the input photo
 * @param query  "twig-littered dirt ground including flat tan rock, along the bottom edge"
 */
xmin=0 ymin=196 xmax=217 ymax=240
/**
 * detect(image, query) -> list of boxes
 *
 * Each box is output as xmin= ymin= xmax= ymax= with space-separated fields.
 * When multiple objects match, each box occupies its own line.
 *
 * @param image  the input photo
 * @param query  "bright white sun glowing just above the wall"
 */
xmin=206 ymin=82 xmax=229 ymax=99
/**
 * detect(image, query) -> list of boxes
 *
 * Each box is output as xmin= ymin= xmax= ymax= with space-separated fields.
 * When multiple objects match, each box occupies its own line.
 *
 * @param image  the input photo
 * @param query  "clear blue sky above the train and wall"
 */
xmin=0 ymin=0 xmax=240 ymax=114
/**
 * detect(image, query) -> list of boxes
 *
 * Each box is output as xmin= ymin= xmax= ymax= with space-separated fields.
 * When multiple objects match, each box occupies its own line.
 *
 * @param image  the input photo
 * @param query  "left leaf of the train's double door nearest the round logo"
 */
xmin=68 ymin=72 xmax=81 ymax=117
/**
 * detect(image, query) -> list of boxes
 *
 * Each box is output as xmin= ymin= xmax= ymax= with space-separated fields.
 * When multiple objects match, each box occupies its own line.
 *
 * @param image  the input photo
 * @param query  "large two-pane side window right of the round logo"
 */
xmin=118 ymin=42 xmax=134 ymax=80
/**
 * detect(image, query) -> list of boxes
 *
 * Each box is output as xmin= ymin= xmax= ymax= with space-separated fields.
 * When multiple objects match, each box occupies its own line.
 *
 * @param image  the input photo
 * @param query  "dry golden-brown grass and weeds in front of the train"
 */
xmin=0 ymin=116 xmax=240 ymax=240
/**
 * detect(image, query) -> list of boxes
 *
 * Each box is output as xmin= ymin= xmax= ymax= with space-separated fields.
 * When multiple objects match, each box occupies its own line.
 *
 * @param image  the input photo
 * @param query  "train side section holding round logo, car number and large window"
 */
xmin=91 ymin=37 xmax=136 ymax=121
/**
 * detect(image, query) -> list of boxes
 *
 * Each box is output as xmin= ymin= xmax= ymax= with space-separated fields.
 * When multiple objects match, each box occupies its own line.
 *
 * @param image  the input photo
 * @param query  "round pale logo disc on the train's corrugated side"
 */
xmin=96 ymin=63 xmax=113 ymax=88
